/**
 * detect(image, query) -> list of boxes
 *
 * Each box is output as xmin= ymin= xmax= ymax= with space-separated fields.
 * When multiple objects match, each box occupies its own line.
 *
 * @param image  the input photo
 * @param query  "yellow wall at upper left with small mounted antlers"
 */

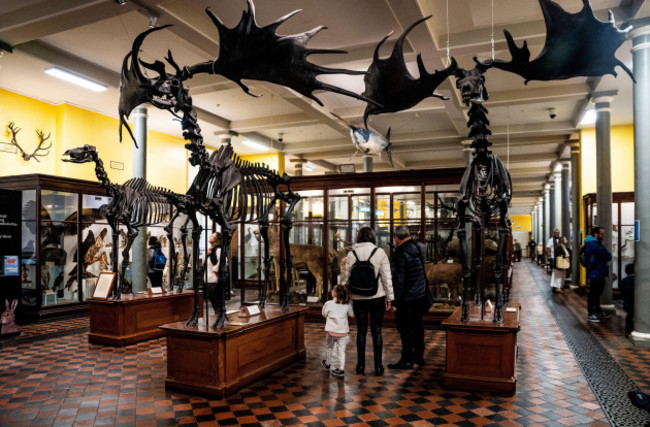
xmin=0 ymin=89 xmax=187 ymax=192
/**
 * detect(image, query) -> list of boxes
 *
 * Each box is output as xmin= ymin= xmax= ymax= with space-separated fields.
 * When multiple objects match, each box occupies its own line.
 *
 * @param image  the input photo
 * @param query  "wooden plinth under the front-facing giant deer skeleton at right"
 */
xmin=442 ymin=304 xmax=519 ymax=395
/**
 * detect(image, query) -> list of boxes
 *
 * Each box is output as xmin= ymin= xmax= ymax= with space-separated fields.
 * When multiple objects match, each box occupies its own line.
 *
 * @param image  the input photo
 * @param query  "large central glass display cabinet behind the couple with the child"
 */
xmin=237 ymin=168 xmax=465 ymax=314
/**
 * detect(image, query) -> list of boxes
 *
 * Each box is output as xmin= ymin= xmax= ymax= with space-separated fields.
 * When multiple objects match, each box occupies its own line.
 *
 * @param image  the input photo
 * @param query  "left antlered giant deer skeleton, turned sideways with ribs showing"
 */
xmin=119 ymin=0 xmax=375 ymax=327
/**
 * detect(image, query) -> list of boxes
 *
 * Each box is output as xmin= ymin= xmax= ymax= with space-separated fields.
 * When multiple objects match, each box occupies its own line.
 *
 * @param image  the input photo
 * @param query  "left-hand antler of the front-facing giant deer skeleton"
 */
xmin=362 ymin=16 xmax=458 ymax=127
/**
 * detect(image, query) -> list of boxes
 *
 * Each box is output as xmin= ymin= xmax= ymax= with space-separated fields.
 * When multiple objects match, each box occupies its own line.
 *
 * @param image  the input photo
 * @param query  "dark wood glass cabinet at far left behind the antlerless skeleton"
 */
xmin=0 ymin=174 xmax=197 ymax=318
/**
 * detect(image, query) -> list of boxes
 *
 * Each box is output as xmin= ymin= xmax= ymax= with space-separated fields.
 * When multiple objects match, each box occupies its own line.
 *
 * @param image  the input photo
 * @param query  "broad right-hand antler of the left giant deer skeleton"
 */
xmin=202 ymin=0 xmax=373 ymax=106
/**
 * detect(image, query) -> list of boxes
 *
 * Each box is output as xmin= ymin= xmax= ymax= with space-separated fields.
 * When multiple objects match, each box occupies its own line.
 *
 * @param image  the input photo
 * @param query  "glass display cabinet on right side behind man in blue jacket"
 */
xmin=580 ymin=192 xmax=634 ymax=289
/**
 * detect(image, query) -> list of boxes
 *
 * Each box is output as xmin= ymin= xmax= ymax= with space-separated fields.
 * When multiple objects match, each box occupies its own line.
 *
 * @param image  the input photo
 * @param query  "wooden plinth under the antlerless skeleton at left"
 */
xmin=88 ymin=290 xmax=203 ymax=346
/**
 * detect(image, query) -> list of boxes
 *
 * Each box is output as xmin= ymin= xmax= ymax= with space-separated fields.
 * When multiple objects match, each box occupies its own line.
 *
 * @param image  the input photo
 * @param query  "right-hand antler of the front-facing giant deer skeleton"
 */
xmin=483 ymin=0 xmax=636 ymax=83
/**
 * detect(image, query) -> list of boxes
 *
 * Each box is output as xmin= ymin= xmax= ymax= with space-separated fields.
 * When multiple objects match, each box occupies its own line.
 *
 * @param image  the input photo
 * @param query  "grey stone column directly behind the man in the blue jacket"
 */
xmin=593 ymin=91 xmax=612 ymax=309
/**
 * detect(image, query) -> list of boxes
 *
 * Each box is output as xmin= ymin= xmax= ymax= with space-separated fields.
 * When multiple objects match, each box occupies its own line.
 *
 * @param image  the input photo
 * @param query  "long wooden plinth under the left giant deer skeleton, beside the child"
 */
xmin=160 ymin=306 xmax=306 ymax=397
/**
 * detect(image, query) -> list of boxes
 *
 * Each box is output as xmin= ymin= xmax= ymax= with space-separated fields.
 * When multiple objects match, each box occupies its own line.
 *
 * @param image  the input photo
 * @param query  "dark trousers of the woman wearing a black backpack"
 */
xmin=352 ymin=298 xmax=386 ymax=368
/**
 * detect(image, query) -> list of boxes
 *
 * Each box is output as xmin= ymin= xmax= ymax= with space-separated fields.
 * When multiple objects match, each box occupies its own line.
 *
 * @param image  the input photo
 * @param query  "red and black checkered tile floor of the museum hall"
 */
xmin=0 ymin=262 xmax=650 ymax=426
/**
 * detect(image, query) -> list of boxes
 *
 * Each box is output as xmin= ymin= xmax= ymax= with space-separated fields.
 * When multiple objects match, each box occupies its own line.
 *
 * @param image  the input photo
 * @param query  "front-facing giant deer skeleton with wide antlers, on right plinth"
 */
xmin=356 ymin=0 xmax=634 ymax=323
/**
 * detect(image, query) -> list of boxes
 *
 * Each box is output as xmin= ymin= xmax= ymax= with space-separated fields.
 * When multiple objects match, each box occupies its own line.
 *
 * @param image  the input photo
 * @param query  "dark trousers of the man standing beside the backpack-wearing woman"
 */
xmin=395 ymin=298 xmax=425 ymax=362
